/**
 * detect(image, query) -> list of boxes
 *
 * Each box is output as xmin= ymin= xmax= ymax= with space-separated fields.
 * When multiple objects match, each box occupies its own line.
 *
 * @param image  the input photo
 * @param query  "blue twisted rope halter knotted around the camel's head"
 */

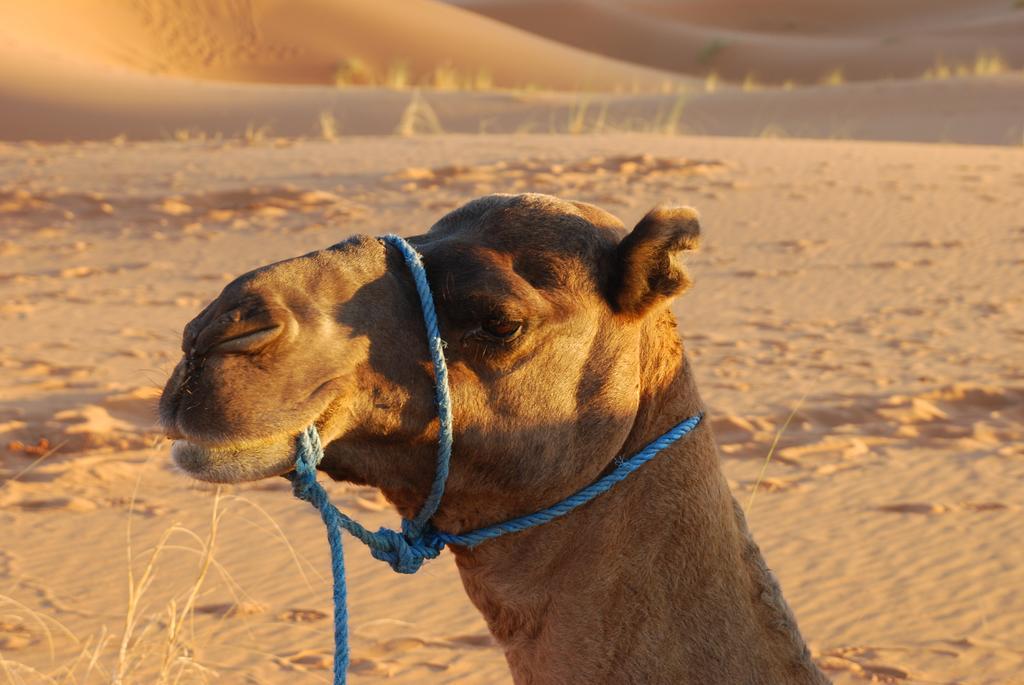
xmin=286 ymin=236 xmax=703 ymax=685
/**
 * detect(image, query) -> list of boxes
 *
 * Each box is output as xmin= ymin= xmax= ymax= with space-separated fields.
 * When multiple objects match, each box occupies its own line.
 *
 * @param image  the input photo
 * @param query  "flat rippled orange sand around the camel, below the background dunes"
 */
xmin=0 ymin=134 xmax=1024 ymax=685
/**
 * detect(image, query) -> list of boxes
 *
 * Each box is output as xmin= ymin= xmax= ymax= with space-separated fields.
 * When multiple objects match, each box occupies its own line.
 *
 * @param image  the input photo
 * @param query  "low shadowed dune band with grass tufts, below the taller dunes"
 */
xmin=0 ymin=48 xmax=1024 ymax=145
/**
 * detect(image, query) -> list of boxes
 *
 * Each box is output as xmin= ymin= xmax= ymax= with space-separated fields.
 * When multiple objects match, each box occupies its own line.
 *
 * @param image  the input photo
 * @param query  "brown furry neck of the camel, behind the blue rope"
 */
xmin=456 ymin=361 xmax=827 ymax=684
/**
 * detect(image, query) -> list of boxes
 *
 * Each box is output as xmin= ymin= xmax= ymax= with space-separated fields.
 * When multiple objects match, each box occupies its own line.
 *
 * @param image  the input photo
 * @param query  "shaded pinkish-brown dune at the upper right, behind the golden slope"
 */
xmin=454 ymin=0 xmax=1024 ymax=83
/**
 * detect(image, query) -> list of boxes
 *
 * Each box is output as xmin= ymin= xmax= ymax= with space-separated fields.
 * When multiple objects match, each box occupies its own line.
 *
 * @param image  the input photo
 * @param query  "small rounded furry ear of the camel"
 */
xmin=611 ymin=207 xmax=700 ymax=315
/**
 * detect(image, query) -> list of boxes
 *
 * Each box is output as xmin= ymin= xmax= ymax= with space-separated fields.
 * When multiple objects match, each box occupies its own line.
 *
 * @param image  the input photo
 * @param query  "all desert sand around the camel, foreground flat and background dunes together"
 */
xmin=0 ymin=0 xmax=1024 ymax=685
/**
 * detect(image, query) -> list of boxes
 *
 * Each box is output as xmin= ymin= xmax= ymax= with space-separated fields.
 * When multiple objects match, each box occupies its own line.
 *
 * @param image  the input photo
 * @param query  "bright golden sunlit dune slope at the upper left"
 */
xmin=0 ymin=0 xmax=688 ymax=90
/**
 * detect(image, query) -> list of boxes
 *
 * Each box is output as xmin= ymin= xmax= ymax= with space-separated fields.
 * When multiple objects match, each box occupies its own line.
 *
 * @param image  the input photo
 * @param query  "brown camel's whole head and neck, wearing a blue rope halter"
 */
xmin=160 ymin=194 xmax=828 ymax=685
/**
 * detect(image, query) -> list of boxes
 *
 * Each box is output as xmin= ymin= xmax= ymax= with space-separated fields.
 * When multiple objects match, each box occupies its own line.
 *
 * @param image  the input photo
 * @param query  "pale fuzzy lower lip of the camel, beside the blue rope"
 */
xmin=171 ymin=434 xmax=295 ymax=483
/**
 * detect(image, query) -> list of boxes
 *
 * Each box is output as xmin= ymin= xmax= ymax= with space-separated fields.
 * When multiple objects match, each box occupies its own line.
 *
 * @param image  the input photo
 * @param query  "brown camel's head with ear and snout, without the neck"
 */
xmin=160 ymin=195 xmax=699 ymax=530
